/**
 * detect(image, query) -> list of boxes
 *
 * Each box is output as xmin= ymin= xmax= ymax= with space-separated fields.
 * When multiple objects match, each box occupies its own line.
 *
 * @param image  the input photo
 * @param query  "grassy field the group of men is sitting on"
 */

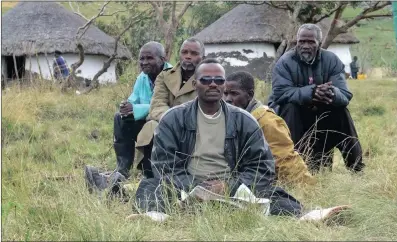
xmin=1 ymin=80 xmax=397 ymax=241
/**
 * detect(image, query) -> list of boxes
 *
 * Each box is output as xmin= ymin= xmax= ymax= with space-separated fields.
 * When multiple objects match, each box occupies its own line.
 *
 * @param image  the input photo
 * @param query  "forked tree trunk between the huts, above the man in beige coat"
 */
xmin=150 ymin=1 xmax=192 ymax=60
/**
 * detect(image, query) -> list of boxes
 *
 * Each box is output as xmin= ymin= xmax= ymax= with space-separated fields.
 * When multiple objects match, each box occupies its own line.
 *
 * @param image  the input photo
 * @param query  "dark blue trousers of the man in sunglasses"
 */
xmin=135 ymin=178 xmax=302 ymax=216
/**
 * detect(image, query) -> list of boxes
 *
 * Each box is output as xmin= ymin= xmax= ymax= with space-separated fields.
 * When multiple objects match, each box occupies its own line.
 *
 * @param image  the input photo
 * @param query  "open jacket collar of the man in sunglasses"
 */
xmin=184 ymin=97 xmax=236 ymax=138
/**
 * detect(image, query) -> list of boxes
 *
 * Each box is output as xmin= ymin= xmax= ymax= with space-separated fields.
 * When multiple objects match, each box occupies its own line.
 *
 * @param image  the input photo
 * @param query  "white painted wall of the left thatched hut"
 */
xmin=25 ymin=54 xmax=116 ymax=83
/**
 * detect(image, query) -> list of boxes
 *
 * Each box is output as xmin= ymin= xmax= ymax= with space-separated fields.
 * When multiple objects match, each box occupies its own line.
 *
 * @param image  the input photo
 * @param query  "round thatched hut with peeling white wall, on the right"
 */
xmin=194 ymin=4 xmax=359 ymax=79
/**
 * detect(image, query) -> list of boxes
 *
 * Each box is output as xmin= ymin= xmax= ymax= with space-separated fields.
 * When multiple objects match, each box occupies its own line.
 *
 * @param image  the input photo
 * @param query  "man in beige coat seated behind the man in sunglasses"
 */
xmin=136 ymin=38 xmax=205 ymax=175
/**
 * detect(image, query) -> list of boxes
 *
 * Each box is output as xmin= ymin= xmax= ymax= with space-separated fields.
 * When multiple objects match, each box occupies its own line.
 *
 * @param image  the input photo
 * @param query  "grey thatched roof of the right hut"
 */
xmin=195 ymin=4 xmax=359 ymax=44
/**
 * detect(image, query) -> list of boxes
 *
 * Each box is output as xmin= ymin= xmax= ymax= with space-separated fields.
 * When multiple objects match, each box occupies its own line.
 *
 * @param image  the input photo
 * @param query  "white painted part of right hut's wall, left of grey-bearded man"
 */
xmin=205 ymin=43 xmax=276 ymax=66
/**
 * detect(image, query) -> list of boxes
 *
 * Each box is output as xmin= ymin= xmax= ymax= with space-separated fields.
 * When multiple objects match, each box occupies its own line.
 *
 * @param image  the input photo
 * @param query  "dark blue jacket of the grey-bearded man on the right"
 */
xmin=269 ymin=49 xmax=353 ymax=108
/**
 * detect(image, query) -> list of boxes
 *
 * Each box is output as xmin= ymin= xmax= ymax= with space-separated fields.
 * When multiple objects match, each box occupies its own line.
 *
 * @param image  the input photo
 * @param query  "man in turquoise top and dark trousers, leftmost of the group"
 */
xmin=85 ymin=41 xmax=172 ymax=197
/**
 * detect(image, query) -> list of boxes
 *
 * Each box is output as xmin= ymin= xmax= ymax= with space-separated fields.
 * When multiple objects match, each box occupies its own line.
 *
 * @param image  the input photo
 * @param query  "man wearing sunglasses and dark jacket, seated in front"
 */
xmin=132 ymin=59 xmax=301 ymax=221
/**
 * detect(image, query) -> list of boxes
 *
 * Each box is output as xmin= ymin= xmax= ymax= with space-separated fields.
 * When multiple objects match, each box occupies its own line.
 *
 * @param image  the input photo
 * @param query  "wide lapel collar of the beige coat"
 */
xmin=164 ymin=62 xmax=194 ymax=98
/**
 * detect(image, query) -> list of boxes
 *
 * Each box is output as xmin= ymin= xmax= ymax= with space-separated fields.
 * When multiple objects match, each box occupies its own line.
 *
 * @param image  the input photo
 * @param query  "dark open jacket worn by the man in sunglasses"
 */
xmin=151 ymin=98 xmax=275 ymax=195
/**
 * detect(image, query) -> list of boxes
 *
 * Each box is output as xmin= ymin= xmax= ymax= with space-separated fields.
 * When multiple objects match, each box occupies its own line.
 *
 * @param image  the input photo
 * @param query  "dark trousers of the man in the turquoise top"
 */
xmin=113 ymin=113 xmax=153 ymax=178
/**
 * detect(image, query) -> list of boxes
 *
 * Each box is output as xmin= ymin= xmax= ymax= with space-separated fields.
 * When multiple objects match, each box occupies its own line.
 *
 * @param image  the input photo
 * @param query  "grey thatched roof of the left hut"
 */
xmin=1 ymin=2 xmax=131 ymax=58
